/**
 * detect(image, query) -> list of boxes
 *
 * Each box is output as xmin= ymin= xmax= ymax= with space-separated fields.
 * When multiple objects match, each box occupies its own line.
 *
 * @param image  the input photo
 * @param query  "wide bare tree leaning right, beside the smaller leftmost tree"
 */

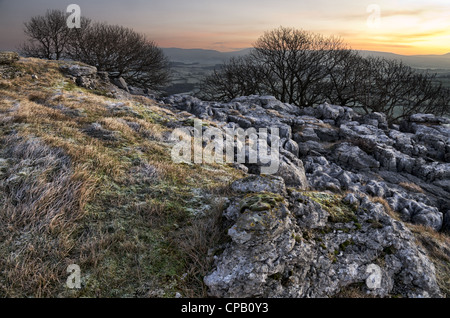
xmin=67 ymin=23 xmax=169 ymax=89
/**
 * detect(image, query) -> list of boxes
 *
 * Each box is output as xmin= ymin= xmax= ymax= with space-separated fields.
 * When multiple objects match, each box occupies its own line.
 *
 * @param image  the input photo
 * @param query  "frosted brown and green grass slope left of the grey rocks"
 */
xmin=0 ymin=59 xmax=240 ymax=297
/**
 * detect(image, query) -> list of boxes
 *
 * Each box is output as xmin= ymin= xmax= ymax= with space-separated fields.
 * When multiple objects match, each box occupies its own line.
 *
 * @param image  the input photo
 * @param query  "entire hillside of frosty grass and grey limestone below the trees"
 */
xmin=0 ymin=54 xmax=450 ymax=298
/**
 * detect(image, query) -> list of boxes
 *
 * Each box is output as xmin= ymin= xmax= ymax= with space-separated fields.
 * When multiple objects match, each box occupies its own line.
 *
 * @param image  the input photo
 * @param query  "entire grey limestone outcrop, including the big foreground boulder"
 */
xmin=162 ymin=96 xmax=450 ymax=297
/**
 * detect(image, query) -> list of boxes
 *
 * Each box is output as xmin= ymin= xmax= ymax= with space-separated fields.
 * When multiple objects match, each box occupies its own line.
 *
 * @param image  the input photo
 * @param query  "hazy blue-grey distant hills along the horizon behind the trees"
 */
xmin=163 ymin=48 xmax=450 ymax=70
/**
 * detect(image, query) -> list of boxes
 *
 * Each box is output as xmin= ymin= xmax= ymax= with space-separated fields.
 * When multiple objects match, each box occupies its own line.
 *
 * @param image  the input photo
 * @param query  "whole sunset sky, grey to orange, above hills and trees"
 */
xmin=0 ymin=0 xmax=450 ymax=55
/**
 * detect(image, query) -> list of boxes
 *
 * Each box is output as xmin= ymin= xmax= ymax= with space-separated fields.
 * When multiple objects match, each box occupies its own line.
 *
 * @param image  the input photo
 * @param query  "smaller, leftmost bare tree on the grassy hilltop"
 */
xmin=19 ymin=10 xmax=70 ymax=60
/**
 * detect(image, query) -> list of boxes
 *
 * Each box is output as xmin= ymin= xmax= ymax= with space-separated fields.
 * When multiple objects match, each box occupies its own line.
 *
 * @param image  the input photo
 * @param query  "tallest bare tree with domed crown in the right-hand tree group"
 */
xmin=253 ymin=27 xmax=344 ymax=106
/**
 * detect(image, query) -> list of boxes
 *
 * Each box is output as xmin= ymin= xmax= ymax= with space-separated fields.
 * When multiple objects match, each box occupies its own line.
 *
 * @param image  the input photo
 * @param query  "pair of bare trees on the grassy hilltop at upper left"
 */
xmin=20 ymin=10 xmax=170 ymax=90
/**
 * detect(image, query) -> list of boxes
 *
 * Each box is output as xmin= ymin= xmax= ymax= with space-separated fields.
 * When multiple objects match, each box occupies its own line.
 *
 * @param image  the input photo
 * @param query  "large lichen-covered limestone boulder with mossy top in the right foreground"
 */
xmin=204 ymin=184 xmax=442 ymax=298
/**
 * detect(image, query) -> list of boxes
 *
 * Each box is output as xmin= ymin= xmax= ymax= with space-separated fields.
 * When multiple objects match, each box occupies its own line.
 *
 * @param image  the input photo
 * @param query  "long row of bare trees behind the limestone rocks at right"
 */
xmin=200 ymin=27 xmax=450 ymax=122
